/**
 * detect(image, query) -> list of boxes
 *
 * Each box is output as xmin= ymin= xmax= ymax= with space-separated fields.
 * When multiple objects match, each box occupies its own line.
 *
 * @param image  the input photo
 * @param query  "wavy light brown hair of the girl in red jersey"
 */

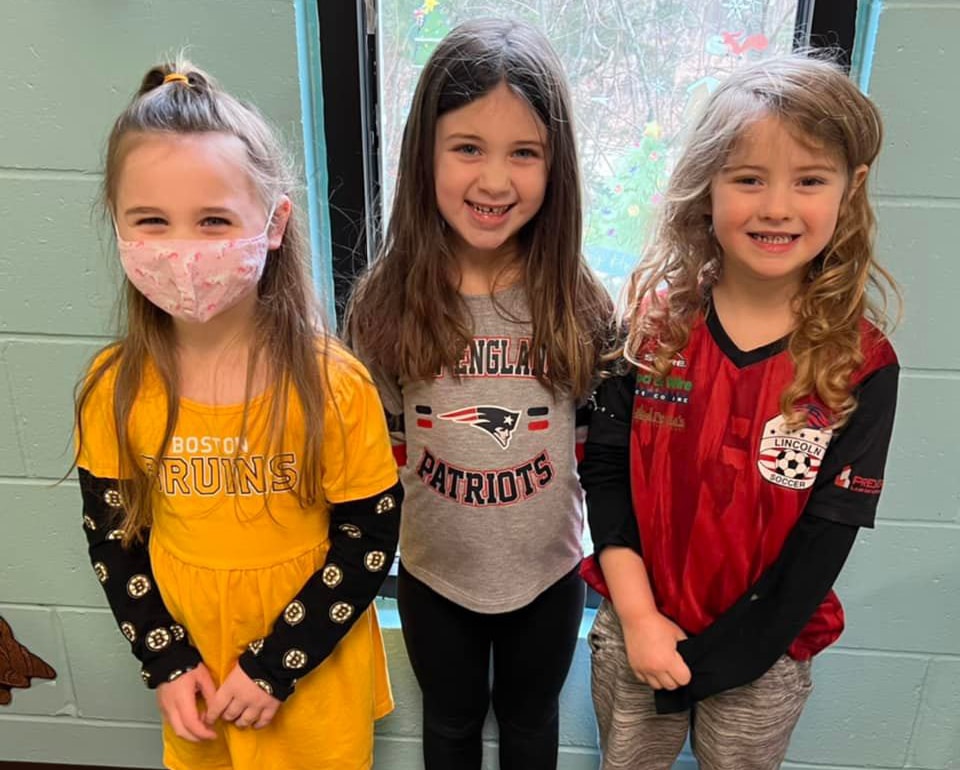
xmin=627 ymin=54 xmax=900 ymax=427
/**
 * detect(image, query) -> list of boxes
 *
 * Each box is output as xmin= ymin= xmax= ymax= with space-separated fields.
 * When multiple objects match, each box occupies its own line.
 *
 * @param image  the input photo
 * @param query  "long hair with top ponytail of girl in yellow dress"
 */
xmin=76 ymin=58 xmax=327 ymax=543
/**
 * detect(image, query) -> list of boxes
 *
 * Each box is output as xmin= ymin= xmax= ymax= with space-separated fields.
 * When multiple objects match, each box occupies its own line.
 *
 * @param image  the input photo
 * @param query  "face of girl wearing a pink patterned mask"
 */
xmin=113 ymin=131 xmax=291 ymax=331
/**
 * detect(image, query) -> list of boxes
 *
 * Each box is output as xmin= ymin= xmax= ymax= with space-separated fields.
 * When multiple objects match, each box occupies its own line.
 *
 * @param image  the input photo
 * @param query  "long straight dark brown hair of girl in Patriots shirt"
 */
xmin=346 ymin=19 xmax=612 ymax=397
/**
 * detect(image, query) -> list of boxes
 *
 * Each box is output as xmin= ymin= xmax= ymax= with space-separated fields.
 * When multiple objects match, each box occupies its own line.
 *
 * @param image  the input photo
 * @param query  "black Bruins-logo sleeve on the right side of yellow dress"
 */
xmin=239 ymin=482 xmax=403 ymax=700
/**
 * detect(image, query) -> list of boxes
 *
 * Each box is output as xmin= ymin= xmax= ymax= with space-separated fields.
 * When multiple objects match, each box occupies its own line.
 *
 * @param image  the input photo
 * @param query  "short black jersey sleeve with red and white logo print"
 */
xmin=804 ymin=364 xmax=900 ymax=527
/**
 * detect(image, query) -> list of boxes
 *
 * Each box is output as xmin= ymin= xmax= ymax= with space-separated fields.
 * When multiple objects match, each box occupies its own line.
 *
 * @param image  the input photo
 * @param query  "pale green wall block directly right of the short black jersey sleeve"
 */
xmin=877 ymin=372 xmax=960 ymax=528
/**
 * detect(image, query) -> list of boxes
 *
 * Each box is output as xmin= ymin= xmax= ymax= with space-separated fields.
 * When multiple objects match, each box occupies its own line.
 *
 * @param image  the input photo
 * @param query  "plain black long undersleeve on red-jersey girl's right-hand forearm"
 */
xmin=655 ymin=515 xmax=858 ymax=714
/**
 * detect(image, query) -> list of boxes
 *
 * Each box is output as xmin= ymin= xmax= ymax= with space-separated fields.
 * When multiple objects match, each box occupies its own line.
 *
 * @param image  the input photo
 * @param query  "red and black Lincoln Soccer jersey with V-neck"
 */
xmin=582 ymin=312 xmax=899 ymax=659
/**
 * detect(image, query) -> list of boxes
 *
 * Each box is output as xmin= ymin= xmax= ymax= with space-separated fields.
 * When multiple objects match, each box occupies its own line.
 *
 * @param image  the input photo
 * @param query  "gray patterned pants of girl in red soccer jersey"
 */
xmin=587 ymin=601 xmax=813 ymax=770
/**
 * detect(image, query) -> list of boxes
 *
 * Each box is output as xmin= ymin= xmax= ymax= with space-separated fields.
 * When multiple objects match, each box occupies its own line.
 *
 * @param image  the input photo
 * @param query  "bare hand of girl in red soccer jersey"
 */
xmin=620 ymin=612 xmax=690 ymax=690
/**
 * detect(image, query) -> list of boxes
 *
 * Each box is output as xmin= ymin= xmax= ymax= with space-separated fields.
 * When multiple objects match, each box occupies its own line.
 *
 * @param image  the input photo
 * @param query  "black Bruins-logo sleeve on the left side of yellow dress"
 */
xmin=77 ymin=468 xmax=201 ymax=689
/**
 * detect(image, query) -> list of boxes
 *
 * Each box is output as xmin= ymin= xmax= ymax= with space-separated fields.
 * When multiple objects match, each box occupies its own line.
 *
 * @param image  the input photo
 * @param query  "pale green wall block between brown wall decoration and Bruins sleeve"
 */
xmin=58 ymin=609 xmax=160 ymax=720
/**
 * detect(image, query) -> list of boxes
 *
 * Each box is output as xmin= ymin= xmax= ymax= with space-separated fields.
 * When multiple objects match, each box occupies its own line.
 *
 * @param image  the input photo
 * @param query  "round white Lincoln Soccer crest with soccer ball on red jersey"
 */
xmin=757 ymin=404 xmax=833 ymax=489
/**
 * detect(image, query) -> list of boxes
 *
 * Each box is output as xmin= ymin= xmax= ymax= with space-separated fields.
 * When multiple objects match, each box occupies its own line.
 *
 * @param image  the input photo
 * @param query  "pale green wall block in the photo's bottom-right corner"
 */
xmin=909 ymin=658 xmax=960 ymax=770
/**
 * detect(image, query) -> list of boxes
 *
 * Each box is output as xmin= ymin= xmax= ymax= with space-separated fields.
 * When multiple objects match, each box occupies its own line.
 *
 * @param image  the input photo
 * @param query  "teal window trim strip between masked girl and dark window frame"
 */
xmin=294 ymin=0 xmax=336 ymax=320
